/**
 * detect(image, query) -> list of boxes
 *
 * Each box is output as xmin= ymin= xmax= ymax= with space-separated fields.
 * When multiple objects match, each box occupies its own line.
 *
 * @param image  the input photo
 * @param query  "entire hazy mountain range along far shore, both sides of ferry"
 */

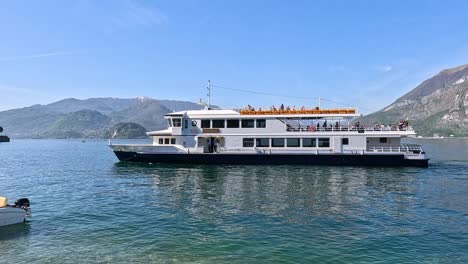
xmin=0 ymin=64 xmax=468 ymax=138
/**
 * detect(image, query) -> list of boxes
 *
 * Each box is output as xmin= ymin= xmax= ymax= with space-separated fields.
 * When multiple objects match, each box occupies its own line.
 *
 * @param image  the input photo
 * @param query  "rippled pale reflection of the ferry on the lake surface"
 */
xmin=115 ymin=163 xmax=419 ymax=222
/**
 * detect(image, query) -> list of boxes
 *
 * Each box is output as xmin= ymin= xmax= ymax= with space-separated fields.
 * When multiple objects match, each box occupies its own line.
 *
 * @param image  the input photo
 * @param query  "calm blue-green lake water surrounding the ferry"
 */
xmin=0 ymin=139 xmax=468 ymax=264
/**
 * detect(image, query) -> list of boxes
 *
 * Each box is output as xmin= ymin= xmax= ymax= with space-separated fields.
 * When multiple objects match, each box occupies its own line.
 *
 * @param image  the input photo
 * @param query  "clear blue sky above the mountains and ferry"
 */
xmin=0 ymin=0 xmax=468 ymax=112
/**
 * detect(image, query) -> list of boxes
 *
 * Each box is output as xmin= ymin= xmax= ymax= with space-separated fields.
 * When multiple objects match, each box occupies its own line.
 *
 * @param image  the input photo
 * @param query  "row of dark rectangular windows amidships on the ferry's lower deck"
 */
xmin=242 ymin=138 xmax=330 ymax=148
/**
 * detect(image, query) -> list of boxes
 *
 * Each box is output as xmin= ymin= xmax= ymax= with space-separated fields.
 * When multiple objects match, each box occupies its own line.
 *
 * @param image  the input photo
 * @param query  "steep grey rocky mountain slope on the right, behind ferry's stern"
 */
xmin=363 ymin=64 xmax=468 ymax=136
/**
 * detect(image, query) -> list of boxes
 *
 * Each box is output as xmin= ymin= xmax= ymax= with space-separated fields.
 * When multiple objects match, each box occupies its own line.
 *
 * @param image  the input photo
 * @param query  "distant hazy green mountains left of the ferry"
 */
xmin=0 ymin=97 xmax=202 ymax=138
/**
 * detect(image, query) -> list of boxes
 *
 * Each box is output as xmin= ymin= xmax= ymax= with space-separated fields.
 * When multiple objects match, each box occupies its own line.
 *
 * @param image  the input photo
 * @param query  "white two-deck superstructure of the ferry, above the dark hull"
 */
xmin=147 ymin=109 xmax=415 ymax=154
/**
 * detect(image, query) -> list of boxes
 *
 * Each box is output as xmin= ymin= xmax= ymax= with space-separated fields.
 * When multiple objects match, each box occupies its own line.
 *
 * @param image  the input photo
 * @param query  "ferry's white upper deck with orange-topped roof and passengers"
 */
xmin=160 ymin=108 xmax=415 ymax=136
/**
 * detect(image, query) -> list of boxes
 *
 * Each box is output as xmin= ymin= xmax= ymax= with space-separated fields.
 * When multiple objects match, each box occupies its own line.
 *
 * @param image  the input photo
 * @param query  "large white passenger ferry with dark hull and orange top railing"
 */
xmin=109 ymin=95 xmax=429 ymax=167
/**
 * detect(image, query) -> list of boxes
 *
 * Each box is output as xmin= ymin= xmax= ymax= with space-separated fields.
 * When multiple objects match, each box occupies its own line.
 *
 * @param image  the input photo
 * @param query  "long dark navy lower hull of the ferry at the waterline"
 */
xmin=114 ymin=151 xmax=429 ymax=167
